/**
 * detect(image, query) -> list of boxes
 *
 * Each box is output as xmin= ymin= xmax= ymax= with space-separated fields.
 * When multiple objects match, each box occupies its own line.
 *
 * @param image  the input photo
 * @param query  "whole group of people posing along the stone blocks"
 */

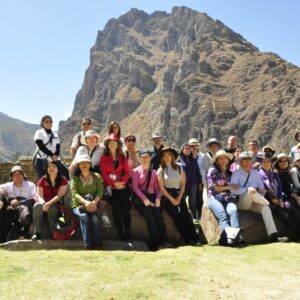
xmin=0 ymin=115 xmax=300 ymax=251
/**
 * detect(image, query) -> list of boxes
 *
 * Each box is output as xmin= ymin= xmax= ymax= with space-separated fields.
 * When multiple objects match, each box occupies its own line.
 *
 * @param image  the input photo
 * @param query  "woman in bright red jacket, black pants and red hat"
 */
xmin=100 ymin=133 xmax=131 ymax=242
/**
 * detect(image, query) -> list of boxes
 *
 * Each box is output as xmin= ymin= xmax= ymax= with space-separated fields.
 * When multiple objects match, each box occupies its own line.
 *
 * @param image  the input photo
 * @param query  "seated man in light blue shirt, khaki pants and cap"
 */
xmin=230 ymin=151 xmax=286 ymax=242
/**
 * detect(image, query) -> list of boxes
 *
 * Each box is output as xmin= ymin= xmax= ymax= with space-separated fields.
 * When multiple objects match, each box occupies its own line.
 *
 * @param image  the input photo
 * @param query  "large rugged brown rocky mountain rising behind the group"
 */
xmin=59 ymin=7 xmax=300 ymax=149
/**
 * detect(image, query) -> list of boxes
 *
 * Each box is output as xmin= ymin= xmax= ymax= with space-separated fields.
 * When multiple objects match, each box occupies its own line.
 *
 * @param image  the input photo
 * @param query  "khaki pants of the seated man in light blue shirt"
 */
xmin=239 ymin=192 xmax=277 ymax=236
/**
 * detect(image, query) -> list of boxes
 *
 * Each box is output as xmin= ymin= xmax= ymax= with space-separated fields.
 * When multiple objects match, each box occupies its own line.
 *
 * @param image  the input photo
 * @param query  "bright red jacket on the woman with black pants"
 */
xmin=100 ymin=154 xmax=130 ymax=188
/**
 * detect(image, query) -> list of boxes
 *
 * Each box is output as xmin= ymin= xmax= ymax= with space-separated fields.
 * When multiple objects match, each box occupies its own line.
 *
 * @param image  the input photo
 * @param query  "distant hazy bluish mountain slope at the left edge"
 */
xmin=0 ymin=112 xmax=39 ymax=161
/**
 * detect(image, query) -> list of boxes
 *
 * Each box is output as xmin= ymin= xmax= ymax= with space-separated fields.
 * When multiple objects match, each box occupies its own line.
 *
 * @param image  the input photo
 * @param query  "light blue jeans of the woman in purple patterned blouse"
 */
xmin=208 ymin=196 xmax=240 ymax=231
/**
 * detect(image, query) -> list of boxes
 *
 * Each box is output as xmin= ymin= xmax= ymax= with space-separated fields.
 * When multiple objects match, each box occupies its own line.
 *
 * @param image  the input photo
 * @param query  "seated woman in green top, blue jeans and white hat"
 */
xmin=71 ymin=154 xmax=104 ymax=250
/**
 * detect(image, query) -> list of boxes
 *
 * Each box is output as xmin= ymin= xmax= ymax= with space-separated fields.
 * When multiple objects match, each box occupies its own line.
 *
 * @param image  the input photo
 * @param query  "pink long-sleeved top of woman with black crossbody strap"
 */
xmin=131 ymin=166 xmax=161 ymax=201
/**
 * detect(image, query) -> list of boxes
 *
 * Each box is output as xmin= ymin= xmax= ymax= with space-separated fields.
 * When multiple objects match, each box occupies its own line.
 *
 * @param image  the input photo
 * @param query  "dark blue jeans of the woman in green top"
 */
xmin=73 ymin=207 xmax=102 ymax=247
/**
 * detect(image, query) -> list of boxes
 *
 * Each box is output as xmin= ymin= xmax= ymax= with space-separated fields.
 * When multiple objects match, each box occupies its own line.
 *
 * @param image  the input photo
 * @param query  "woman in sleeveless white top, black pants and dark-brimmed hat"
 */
xmin=157 ymin=147 xmax=201 ymax=246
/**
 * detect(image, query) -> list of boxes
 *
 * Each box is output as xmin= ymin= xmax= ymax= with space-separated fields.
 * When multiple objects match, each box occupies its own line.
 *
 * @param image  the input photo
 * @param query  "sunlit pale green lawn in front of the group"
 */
xmin=0 ymin=243 xmax=300 ymax=300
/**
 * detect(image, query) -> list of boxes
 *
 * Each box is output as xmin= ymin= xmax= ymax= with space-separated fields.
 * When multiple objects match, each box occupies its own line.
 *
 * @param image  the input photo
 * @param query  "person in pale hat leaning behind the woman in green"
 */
xmin=69 ymin=129 xmax=104 ymax=175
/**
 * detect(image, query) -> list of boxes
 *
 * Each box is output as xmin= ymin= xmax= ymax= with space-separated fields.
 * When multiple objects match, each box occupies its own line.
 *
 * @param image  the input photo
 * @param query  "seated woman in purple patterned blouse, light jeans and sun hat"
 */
xmin=207 ymin=150 xmax=240 ymax=239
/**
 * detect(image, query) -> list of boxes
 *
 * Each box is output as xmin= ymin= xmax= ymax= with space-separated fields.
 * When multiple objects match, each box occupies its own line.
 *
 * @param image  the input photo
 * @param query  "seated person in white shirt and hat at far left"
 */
xmin=0 ymin=166 xmax=37 ymax=239
